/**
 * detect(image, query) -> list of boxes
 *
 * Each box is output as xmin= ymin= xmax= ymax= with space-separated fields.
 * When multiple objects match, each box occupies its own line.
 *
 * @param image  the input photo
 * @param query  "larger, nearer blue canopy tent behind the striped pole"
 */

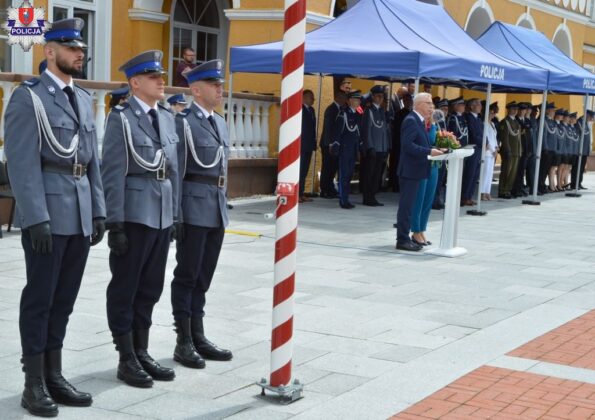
xmin=228 ymin=0 xmax=548 ymax=214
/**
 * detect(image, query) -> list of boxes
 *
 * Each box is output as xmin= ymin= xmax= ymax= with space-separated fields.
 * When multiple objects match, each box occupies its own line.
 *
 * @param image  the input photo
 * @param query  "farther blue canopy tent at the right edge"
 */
xmin=477 ymin=22 xmax=595 ymax=204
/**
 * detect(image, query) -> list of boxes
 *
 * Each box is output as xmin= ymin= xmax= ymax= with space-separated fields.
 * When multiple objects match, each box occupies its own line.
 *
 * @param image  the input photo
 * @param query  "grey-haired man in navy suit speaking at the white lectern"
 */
xmin=396 ymin=92 xmax=442 ymax=251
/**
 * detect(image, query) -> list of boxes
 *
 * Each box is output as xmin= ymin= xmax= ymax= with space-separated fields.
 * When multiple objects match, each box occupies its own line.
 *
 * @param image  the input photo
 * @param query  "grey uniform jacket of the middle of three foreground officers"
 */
xmin=101 ymin=96 xmax=179 ymax=229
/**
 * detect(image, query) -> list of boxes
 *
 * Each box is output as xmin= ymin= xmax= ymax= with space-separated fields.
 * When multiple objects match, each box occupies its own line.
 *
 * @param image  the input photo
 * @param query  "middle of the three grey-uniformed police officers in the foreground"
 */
xmin=101 ymin=50 xmax=179 ymax=388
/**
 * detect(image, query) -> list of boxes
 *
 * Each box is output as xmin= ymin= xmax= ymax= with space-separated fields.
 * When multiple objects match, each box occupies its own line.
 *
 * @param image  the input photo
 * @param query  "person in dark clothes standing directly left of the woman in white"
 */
xmin=461 ymin=98 xmax=483 ymax=206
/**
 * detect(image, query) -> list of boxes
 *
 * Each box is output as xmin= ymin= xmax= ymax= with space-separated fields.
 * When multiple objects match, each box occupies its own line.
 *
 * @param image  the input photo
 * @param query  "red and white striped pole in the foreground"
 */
xmin=263 ymin=0 xmax=306 ymax=400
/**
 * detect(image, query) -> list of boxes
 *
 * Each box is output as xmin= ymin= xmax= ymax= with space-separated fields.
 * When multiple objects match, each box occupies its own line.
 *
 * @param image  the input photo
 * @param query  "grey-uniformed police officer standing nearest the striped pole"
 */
xmin=171 ymin=60 xmax=232 ymax=369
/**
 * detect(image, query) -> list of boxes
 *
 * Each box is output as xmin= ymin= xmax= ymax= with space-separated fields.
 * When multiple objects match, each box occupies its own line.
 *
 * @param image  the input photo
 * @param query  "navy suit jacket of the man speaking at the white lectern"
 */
xmin=397 ymin=112 xmax=432 ymax=179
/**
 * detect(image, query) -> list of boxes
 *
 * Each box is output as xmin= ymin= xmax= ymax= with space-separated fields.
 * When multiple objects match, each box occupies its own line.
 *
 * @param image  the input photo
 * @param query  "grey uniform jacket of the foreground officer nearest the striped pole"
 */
xmin=176 ymin=102 xmax=229 ymax=228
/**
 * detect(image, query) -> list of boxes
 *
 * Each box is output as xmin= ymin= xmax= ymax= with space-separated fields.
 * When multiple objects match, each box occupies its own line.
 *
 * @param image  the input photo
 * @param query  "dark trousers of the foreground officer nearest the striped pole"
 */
xmin=171 ymin=224 xmax=225 ymax=320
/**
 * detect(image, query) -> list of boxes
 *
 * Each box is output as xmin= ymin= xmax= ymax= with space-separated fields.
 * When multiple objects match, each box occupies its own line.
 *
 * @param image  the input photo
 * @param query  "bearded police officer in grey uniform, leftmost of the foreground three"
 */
xmin=5 ymin=18 xmax=105 ymax=417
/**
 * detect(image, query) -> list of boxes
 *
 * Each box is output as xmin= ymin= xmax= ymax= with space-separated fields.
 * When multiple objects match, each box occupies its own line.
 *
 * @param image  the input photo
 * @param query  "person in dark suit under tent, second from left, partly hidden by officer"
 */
xmin=320 ymin=91 xmax=347 ymax=198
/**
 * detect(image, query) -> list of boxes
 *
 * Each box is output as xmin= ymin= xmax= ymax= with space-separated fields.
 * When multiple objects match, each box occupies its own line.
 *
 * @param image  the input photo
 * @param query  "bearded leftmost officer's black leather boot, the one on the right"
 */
xmin=45 ymin=349 xmax=93 ymax=407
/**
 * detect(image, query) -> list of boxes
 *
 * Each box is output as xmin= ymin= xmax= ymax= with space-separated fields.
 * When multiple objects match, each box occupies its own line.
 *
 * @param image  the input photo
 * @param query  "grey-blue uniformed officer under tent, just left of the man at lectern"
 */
xmin=362 ymin=85 xmax=391 ymax=207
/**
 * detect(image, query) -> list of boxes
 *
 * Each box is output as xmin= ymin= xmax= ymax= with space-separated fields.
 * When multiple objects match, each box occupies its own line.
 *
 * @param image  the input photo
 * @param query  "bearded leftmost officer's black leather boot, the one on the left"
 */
xmin=21 ymin=353 xmax=58 ymax=417
